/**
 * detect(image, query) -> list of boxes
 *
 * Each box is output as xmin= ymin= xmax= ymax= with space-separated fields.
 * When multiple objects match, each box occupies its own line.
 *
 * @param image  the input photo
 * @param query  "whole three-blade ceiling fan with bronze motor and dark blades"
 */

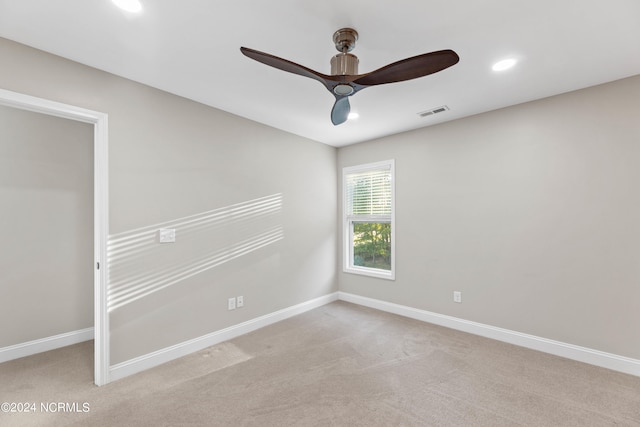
xmin=240 ymin=28 xmax=460 ymax=125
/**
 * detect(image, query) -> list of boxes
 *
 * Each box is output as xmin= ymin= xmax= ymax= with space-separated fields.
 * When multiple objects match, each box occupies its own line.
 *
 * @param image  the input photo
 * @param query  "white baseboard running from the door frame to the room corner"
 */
xmin=109 ymin=292 xmax=338 ymax=381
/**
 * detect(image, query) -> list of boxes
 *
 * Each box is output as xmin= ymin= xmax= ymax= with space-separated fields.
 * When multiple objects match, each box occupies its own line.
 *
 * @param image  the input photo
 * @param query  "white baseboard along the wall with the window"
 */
xmin=338 ymin=292 xmax=640 ymax=377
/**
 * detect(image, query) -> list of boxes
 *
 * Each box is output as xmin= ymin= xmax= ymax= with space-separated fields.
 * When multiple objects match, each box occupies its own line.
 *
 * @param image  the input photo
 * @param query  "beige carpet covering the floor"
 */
xmin=0 ymin=302 xmax=640 ymax=427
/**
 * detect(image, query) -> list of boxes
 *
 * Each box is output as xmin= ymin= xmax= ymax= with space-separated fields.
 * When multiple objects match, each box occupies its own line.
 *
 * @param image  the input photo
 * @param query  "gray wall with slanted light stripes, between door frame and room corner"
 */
xmin=0 ymin=39 xmax=337 ymax=364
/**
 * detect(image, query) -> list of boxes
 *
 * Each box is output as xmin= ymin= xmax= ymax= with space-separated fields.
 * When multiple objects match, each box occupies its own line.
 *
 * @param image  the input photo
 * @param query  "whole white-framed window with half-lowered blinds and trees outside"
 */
xmin=342 ymin=160 xmax=395 ymax=280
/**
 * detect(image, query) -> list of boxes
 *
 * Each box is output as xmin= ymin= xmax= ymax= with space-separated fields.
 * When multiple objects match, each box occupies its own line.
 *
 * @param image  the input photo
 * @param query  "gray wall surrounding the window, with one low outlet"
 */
xmin=338 ymin=76 xmax=640 ymax=359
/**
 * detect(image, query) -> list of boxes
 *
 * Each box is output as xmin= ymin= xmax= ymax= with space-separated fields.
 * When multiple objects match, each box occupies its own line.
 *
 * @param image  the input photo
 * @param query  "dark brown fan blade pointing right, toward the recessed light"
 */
xmin=353 ymin=50 xmax=460 ymax=86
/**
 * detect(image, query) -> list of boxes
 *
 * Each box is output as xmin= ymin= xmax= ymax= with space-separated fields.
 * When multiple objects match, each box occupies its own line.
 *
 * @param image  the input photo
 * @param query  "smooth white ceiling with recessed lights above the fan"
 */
xmin=0 ymin=0 xmax=640 ymax=146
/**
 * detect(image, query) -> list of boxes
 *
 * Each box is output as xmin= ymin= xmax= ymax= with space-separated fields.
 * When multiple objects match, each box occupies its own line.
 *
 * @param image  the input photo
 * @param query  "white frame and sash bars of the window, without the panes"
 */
xmin=342 ymin=159 xmax=396 ymax=280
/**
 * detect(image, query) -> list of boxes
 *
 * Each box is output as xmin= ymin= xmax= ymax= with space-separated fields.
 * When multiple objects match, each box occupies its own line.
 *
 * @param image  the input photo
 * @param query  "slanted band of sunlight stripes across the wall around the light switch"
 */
xmin=107 ymin=193 xmax=284 ymax=312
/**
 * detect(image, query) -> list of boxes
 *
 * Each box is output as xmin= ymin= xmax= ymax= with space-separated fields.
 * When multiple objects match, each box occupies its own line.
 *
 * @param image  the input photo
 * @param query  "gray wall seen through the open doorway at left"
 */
xmin=0 ymin=106 xmax=93 ymax=347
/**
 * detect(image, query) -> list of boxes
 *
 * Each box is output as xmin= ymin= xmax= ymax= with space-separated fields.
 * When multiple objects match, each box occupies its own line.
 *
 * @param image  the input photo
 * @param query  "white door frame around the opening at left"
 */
xmin=0 ymin=89 xmax=109 ymax=386
